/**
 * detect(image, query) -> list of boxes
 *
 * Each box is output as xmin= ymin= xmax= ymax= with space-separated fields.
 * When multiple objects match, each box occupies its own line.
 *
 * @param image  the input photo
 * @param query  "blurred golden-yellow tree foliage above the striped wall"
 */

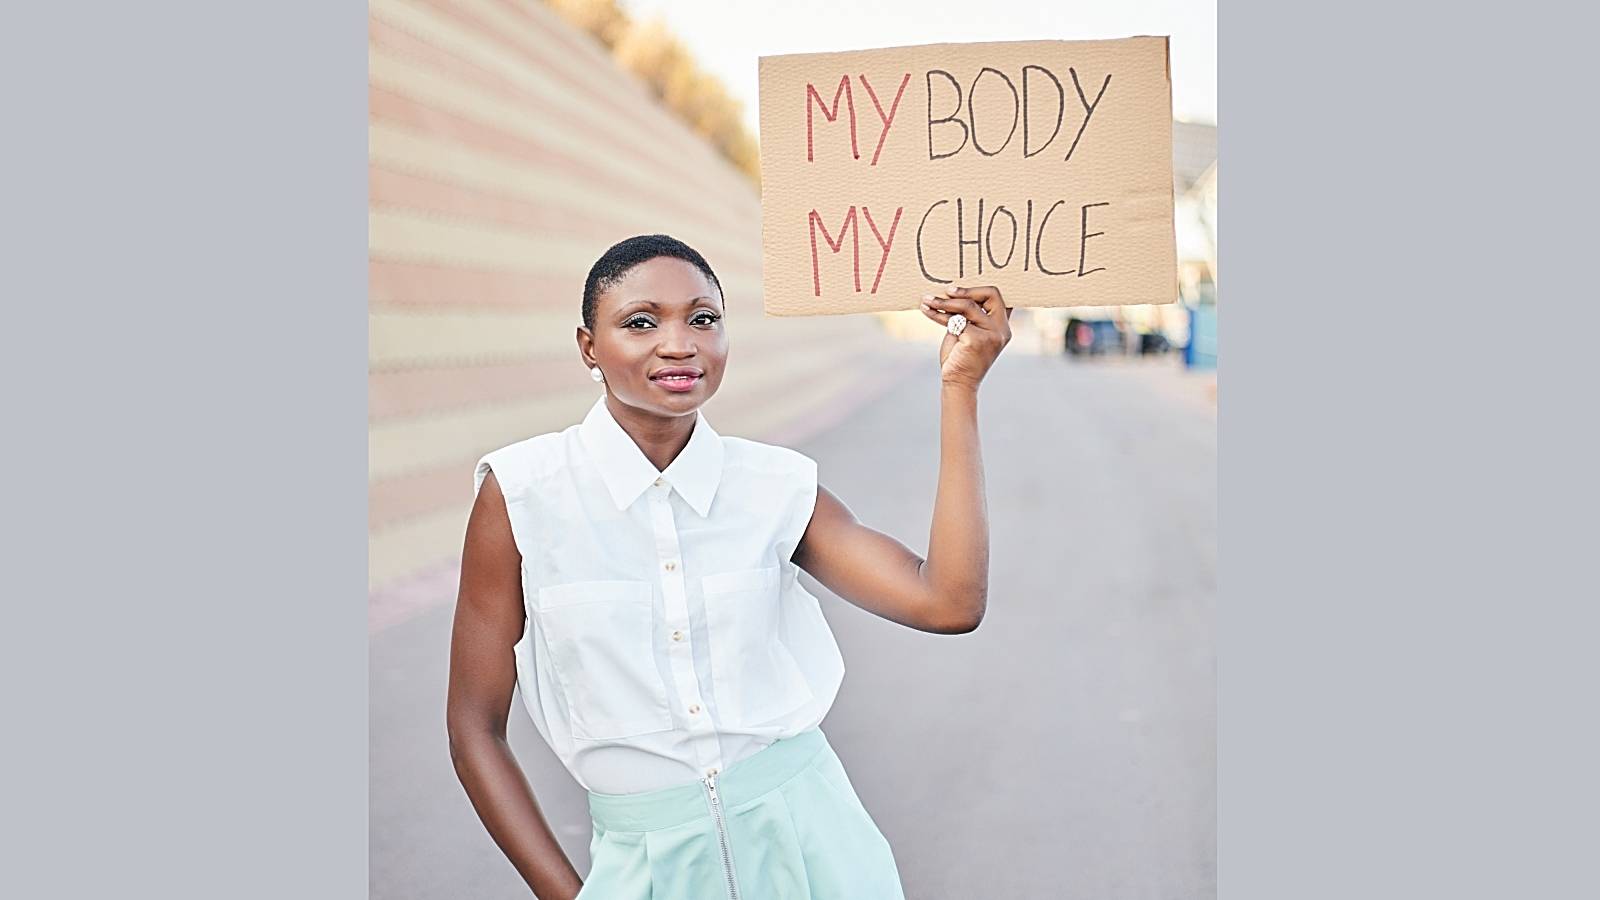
xmin=546 ymin=0 xmax=762 ymax=186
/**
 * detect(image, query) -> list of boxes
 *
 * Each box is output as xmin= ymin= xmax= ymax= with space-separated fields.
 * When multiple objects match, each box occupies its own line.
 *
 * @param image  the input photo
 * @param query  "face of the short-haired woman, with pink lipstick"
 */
xmin=578 ymin=256 xmax=728 ymax=416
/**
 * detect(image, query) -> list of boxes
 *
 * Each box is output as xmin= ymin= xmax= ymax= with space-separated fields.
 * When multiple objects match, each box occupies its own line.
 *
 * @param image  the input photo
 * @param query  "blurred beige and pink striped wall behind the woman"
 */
xmin=368 ymin=0 xmax=926 ymax=626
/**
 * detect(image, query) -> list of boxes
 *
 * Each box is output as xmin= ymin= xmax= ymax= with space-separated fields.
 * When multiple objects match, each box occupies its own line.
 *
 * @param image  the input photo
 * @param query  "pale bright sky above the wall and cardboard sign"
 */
xmin=619 ymin=0 xmax=1216 ymax=135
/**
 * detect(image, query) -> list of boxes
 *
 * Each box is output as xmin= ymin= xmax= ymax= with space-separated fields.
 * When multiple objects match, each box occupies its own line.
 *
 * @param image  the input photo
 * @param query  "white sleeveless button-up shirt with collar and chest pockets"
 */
xmin=474 ymin=397 xmax=845 ymax=794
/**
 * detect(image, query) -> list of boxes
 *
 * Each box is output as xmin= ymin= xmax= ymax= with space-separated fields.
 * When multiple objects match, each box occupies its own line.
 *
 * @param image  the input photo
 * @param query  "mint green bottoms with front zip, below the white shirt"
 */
xmin=578 ymin=729 xmax=904 ymax=900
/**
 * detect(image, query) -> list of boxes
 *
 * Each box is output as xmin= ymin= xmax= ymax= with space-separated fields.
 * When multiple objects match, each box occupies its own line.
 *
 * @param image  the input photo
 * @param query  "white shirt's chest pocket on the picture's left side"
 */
xmin=534 ymin=581 xmax=672 ymax=740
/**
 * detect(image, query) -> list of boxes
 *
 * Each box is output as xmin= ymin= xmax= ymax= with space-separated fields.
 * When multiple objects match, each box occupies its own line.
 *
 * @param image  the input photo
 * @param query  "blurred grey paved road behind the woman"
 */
xmin=371 ymin=354 xmax=1216 ymax=900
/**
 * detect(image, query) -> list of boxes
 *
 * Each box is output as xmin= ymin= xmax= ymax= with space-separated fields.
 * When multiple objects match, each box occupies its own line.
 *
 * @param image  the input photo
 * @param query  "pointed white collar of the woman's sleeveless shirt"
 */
xmin=578 ymin=396 xmax=722 ymax=517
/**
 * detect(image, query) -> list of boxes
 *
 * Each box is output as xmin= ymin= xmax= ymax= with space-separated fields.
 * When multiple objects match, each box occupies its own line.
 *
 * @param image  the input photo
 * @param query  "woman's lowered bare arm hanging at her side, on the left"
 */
xmin=445 ymin=472 xmax=582 ymax=900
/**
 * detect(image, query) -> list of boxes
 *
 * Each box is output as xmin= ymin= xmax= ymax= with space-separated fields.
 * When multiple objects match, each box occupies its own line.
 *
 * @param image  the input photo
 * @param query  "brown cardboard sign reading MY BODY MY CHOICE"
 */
xmin=760 ymin=37 xmax=1178 ymax=315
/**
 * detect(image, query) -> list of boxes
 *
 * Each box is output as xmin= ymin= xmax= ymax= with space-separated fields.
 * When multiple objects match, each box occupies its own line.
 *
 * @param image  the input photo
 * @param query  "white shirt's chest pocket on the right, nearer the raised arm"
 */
xmin=701 ymin=565 xmax=811 ymax=725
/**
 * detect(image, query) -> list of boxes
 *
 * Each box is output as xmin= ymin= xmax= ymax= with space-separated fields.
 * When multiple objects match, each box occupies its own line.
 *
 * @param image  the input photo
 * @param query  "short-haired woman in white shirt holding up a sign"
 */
xmin=448 ymin=235 xmax=1011 ymax=900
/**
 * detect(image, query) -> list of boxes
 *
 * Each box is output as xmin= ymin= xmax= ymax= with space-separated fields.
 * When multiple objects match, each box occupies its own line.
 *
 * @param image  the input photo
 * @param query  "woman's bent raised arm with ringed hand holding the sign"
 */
xmin=794 ymin=287 xmax=1011 ymax=634
